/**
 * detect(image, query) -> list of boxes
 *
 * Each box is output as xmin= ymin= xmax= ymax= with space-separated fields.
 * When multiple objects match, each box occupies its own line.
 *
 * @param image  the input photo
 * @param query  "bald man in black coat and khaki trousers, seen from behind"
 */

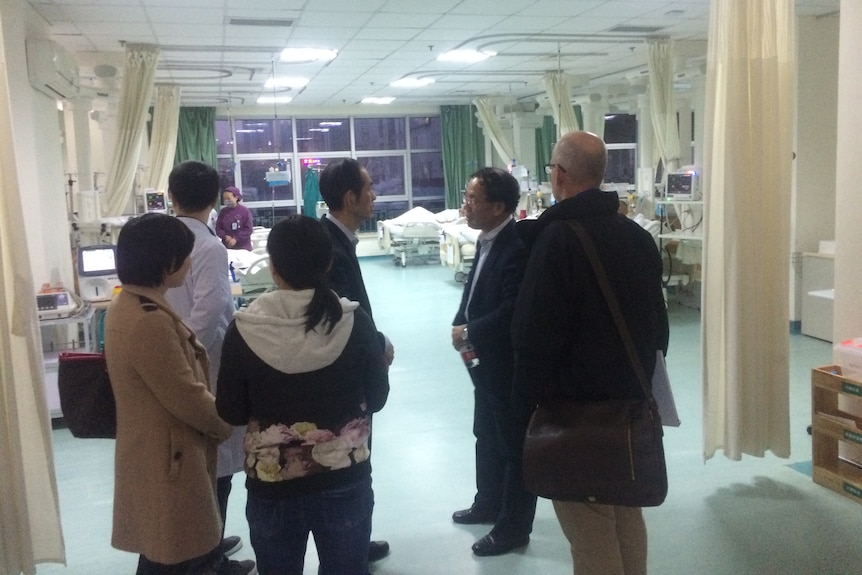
xmin=512 ymin=132 xmax=668 ymax=575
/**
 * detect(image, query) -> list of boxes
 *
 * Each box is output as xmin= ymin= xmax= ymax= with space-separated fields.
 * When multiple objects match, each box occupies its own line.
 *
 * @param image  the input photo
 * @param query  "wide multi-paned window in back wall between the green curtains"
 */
xmin=216 ymin=116 xmax=445 ymax=224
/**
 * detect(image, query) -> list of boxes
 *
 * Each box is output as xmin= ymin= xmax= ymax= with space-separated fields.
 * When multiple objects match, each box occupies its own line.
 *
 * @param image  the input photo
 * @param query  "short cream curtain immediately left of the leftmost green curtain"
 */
xmin=146 ymin=84 xmax=180 ymax=192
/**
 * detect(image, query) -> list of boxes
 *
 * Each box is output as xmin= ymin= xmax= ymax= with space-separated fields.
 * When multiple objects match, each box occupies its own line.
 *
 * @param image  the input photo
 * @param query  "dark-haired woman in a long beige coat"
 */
xmin=105 ymin=214 xmax=233 ymax=575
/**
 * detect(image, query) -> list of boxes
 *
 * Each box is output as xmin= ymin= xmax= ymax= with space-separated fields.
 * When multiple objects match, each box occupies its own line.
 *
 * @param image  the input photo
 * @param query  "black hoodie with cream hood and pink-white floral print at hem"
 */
xmin=216 ymin=290 xmax=389 ymax=497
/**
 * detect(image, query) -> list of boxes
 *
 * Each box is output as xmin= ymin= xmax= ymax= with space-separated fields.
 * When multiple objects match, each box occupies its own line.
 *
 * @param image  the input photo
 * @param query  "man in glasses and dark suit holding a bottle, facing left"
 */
xmin=452 ymin=168 xmax=536 ymax=556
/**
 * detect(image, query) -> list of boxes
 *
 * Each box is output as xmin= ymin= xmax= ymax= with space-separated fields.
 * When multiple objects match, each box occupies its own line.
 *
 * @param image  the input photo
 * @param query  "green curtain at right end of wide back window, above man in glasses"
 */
xmin=440 ymin=105 xmax=485 ymax=208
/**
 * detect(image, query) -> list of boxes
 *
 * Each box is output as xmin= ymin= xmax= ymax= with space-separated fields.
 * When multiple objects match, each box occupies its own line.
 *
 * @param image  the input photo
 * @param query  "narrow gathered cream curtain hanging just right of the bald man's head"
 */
xmin=647 ymin=40 xmax=680 ymax=174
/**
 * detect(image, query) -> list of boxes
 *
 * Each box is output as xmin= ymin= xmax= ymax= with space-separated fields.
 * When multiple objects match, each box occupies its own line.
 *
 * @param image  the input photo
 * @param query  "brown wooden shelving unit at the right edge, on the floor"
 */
xmin=811 ymin=365 xmax=862 ymax=503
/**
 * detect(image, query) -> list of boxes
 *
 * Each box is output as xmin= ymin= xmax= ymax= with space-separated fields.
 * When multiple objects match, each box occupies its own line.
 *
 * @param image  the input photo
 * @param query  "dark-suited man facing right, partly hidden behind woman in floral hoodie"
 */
xmin=320 ymin=158 xmax=395 ymax=561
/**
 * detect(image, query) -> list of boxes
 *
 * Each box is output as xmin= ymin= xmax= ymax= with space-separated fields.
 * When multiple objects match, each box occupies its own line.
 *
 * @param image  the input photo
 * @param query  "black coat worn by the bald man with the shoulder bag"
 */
xmin=512 ymin=189 xmax=668 ymax=403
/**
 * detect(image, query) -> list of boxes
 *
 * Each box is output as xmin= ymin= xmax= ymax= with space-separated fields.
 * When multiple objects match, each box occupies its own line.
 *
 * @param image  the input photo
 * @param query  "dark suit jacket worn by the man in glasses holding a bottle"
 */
xmin=452 ymin=221 xmax=527 ymax=397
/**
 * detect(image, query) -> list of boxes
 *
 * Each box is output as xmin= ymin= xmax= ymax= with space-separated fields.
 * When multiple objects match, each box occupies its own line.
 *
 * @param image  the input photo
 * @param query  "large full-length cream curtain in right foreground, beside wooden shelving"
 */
xmin=701 ymin=0 xmax=795 ymax=460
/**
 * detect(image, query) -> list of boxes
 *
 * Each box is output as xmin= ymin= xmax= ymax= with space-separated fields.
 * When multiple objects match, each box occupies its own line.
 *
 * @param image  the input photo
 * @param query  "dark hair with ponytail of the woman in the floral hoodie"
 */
xmin=266 ymin=214 xmax=343 ymax=333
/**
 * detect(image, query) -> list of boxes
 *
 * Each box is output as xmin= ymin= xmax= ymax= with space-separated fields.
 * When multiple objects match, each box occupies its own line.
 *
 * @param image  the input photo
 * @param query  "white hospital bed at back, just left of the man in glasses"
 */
xmin=377 ymin=206 xmax=457 ymax=267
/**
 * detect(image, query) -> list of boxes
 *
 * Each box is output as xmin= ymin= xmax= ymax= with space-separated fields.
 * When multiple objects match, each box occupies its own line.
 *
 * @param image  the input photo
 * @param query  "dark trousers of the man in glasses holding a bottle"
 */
xmin=473 ymin=384 xmax=536 ymax=535
